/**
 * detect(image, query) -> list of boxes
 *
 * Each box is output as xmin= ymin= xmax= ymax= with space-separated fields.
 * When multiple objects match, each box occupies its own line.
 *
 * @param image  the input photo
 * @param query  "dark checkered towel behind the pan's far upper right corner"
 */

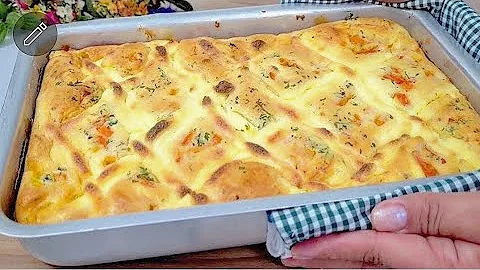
xmin=281 ymin=0 xmax=480 ymax=63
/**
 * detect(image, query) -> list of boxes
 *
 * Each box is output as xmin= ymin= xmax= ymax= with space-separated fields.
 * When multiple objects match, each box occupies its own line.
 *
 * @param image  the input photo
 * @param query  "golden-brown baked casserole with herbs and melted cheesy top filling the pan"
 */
xmin=16 ymin=18 xmax=480 ymax=223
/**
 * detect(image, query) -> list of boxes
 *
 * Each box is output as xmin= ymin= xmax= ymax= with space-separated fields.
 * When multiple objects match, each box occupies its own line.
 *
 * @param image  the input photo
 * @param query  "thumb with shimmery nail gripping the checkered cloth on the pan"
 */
xmin=371 ymin=192 xmax=480 ymax=243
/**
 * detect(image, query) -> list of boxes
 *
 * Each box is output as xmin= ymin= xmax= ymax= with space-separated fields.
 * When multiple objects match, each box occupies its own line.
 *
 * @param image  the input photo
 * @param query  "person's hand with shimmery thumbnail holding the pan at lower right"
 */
xmin=283 ymin=192 xmax=480 ymax=268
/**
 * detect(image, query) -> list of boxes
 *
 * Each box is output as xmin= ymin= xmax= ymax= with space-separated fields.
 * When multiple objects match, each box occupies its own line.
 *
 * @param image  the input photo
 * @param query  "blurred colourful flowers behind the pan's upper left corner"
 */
xmin=0 ymin=0 xmax=193 ymax=43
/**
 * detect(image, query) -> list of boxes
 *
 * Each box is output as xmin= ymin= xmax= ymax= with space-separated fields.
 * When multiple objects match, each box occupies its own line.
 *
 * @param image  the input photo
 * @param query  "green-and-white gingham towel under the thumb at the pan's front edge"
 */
xmin=267 ymin=170 xmax=480 ymax=258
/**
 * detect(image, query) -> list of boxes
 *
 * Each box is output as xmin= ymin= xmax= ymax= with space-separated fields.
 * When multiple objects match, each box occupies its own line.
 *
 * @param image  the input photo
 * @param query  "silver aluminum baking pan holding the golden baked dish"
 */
xmin=0 ymin=3 xmax=480 ymax=266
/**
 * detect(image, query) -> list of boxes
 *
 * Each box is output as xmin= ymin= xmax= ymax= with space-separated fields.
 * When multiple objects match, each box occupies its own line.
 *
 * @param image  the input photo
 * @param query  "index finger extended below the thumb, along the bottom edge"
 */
xmin=292 ymin=231 xmax=480 ymax=268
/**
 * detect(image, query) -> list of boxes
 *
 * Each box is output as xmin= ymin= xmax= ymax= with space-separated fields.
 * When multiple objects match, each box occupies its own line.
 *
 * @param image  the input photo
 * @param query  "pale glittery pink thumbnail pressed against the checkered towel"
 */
xmin=372 ymin=203 xmax=407 ymax=232
